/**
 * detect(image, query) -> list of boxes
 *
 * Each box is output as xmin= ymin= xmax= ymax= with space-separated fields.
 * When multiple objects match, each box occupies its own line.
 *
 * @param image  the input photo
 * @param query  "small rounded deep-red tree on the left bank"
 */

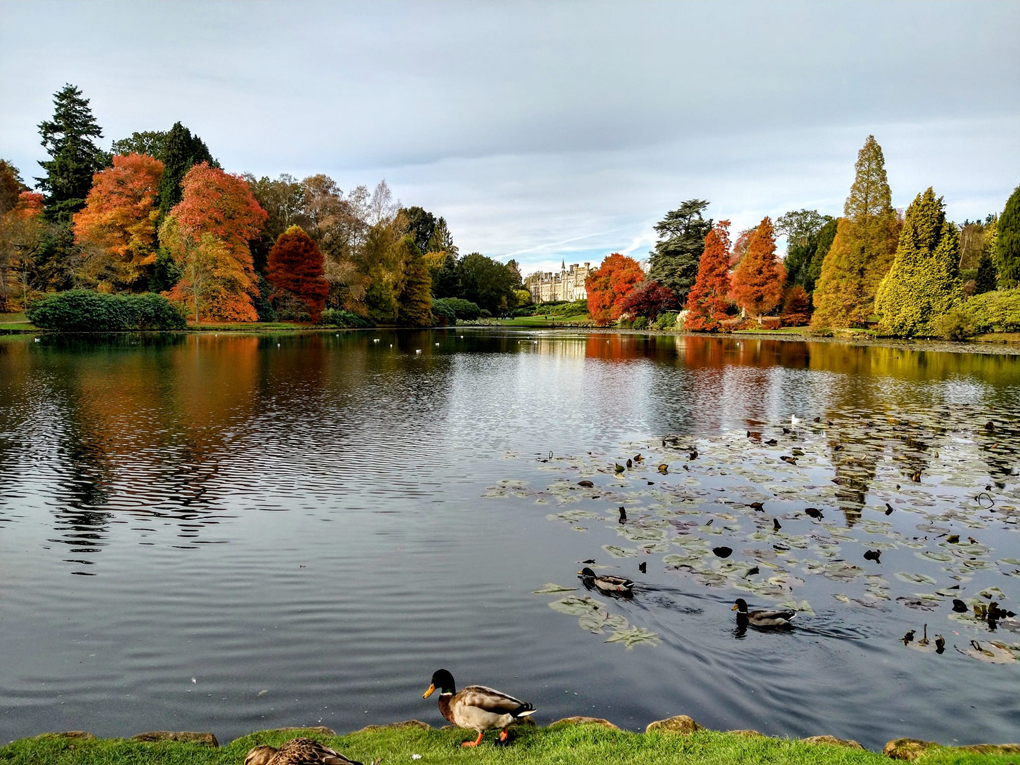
xmin=265 ymin=225 xmax=329 ymax=321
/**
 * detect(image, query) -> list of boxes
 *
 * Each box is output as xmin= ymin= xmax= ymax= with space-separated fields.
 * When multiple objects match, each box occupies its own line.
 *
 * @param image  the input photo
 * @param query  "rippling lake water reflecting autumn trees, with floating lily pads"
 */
xmin=0 ymin=329 xmax=1020 ymax=748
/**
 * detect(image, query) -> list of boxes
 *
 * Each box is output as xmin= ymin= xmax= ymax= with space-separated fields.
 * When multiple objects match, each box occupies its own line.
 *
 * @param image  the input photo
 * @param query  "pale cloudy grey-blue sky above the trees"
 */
xmin=0 ymin=0 xmax=1020 ymax=273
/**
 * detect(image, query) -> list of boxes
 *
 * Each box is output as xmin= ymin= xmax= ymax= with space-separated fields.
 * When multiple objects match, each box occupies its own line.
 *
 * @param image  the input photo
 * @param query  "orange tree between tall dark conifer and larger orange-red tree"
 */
xmin=73 ymin=154 xmax=163 ymax=289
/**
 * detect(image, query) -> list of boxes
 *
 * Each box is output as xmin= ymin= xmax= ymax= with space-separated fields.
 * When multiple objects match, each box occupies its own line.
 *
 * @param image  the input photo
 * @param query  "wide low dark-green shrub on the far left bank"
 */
xmin=26 ymin=290 xmax=187 ymax=333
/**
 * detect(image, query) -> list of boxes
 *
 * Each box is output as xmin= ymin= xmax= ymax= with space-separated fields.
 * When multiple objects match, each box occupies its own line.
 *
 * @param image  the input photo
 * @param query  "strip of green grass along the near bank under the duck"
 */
xmin=0 ymin=725 xmax=1018 ymax=765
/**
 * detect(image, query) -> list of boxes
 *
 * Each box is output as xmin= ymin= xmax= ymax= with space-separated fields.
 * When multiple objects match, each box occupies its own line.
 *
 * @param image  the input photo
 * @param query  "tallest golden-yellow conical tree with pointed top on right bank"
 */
xmin=812 ymin=136 xmax=900 ymax=327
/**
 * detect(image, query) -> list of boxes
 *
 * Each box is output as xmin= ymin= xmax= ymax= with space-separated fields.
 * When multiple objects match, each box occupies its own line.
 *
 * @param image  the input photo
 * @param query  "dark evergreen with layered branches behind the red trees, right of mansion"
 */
xmin=648 ymin=199 xmax=712 ymax=305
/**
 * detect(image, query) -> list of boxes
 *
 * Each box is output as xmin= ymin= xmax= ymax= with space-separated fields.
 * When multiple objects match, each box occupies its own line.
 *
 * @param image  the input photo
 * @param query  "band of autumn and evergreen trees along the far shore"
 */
xmin=0 ymin=85 xmax=1020 ymax=336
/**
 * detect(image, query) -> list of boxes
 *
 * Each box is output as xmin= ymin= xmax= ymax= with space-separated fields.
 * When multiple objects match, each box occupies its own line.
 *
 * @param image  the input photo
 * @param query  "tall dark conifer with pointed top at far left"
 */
xmin=36 ymin=84 xmax=109 ymax=221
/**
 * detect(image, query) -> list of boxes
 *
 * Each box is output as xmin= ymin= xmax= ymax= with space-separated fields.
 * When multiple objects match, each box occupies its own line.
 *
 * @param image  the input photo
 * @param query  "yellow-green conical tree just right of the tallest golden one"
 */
xmin=875 ymin=187 xmax=962 ymax=337
